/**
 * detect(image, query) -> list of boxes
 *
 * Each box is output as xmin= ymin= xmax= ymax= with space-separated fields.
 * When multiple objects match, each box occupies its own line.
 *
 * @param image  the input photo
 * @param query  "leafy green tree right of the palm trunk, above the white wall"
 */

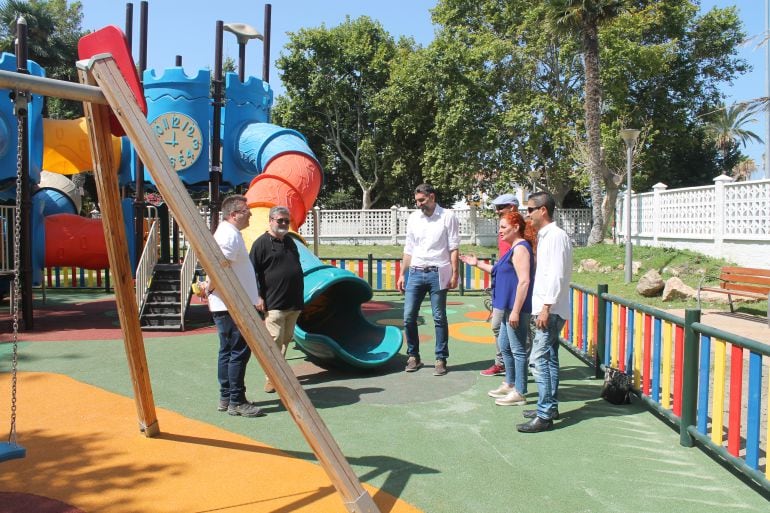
xmin=601 ymin=0 xmax=748 ymax=193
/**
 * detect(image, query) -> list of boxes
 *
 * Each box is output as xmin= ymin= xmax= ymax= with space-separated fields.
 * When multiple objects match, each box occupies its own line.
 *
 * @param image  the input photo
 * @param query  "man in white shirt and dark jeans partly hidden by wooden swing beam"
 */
xmin=206 ymin=194 xmax=264 ymax=417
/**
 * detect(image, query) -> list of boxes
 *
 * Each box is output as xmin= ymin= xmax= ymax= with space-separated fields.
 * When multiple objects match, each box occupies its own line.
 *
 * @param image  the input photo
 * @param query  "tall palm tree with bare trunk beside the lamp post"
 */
xmin=548 ymin=0 xmax=624 ymax=245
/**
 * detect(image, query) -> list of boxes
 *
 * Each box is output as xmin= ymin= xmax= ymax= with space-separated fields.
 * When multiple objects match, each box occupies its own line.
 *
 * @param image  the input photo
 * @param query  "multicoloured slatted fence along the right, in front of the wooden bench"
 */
xmin=563 ymin=284 xmax=770 ymax=491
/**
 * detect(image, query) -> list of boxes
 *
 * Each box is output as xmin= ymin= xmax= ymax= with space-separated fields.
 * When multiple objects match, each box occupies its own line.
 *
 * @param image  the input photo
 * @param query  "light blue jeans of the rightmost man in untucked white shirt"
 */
xmin=530 ymin=314 xmax=565 ymax=419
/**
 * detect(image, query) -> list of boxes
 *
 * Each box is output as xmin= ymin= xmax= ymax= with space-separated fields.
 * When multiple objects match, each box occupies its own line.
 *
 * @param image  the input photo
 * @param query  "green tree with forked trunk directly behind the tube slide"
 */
xmin=274 ymin=16 xmax=409 ymax=209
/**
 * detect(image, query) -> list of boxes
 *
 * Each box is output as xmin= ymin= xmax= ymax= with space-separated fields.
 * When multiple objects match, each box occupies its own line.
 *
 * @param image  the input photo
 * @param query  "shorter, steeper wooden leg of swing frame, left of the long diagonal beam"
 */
xmin=78 ymin=65 xmax=160 ymax=437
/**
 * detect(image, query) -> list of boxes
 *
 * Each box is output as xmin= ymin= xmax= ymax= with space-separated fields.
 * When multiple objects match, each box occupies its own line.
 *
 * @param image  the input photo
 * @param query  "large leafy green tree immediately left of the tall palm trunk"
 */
xmin=424 ymin=0 xmax=579 ymax=203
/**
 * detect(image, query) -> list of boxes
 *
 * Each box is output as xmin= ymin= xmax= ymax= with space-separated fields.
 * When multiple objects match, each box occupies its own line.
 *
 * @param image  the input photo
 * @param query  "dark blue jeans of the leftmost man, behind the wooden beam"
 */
xmin=212 ymin=312 xmax=251 ymax=404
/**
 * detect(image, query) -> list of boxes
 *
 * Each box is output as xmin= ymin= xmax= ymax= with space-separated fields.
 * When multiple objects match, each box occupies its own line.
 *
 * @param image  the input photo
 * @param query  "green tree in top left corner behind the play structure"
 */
xmin=0 ymin=0 xmax=86 ymax=118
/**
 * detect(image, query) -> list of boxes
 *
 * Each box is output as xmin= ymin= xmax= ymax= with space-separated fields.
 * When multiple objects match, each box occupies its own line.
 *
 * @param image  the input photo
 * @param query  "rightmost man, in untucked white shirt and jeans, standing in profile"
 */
xmin=516 ymin=192 xmax=572 ymax=433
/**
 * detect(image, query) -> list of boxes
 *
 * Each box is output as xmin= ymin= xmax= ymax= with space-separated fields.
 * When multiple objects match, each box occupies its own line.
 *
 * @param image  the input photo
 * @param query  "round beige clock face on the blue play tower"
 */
xmin=151 ymin=112 xmax=203 ymax=171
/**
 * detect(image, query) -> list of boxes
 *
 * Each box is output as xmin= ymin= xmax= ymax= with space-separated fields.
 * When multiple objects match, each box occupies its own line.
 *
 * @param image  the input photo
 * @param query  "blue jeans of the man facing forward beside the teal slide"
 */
xmin=404 ymin=271 xmax=449 ymax=360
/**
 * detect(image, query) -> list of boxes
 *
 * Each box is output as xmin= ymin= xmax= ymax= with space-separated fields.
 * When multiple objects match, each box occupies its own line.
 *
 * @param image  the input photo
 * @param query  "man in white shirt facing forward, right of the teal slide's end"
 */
xmin=396 ymin=184 xmax=460 ymax=376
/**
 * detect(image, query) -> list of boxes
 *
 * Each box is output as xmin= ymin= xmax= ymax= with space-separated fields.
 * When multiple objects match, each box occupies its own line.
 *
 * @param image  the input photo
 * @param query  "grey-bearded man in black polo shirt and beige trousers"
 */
xmin=249 ymin=206 xmax=304 ymax=393
